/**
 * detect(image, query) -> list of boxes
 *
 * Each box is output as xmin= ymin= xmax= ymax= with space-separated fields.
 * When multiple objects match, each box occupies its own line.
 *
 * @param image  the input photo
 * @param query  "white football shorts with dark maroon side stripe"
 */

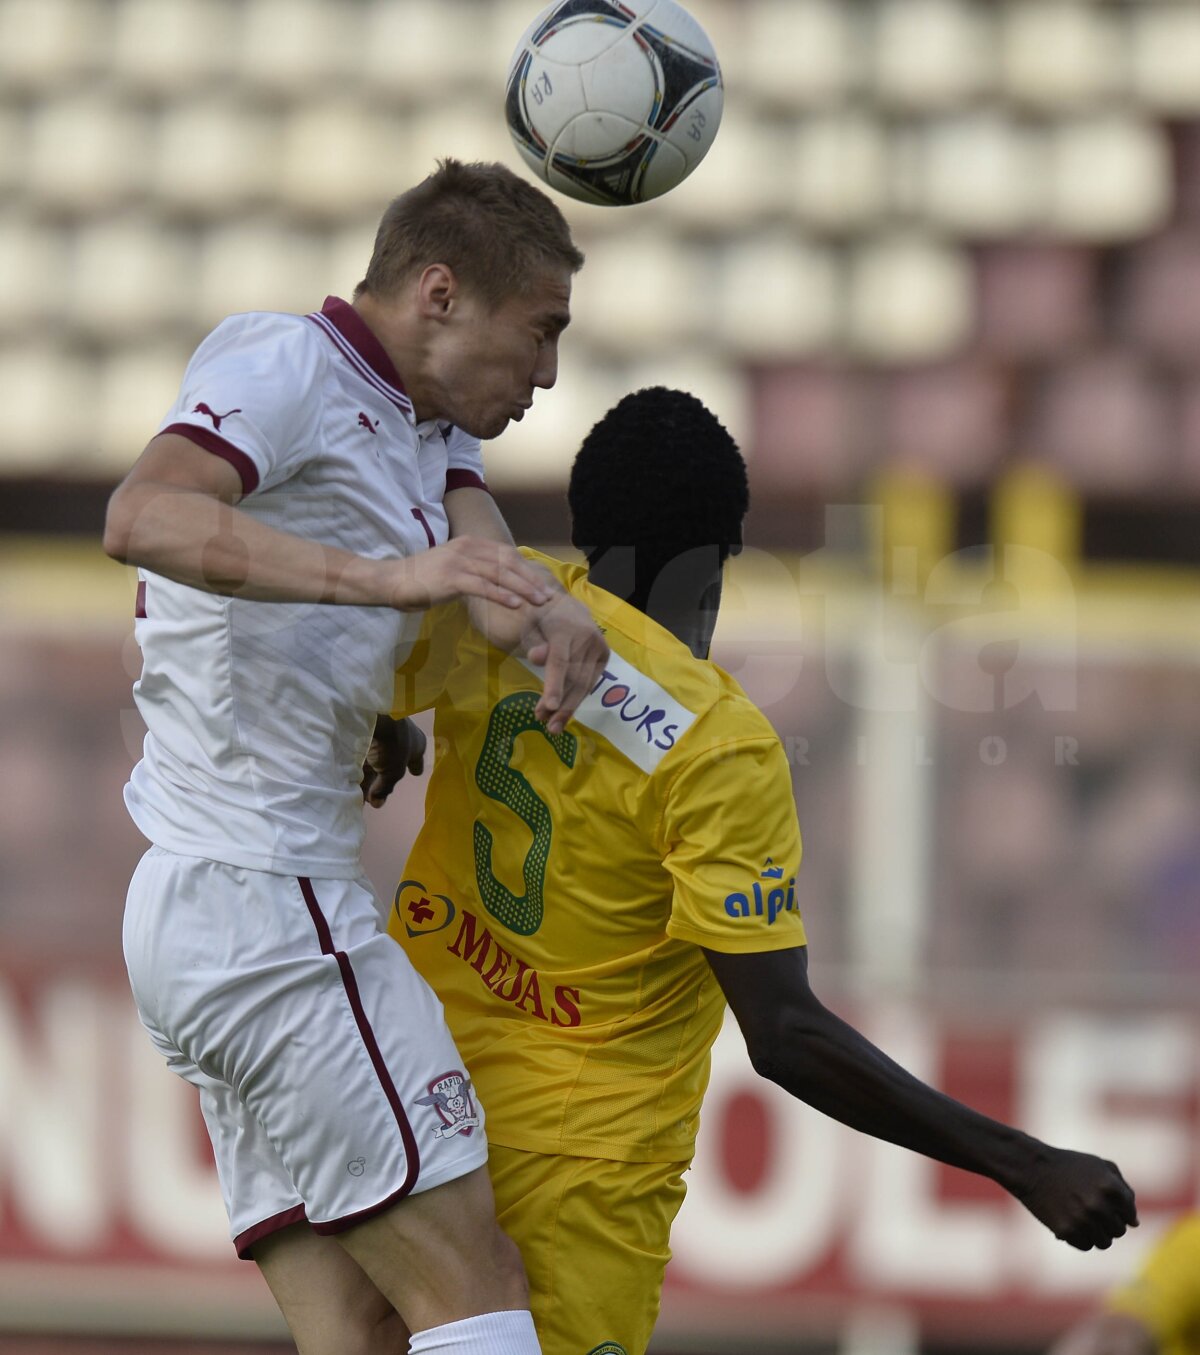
xmin=116 ymin=847 xmax=488 ymax=1256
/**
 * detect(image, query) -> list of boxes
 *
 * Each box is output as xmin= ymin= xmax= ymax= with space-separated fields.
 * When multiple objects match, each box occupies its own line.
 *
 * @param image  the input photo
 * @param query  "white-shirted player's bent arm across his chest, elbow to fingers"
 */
xmin=104 ymin=434 xmax=551 ymax=611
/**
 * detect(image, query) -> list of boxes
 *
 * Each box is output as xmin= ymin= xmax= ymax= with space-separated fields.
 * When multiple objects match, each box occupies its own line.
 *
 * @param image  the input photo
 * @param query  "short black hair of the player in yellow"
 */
xmin=567 ymin=386 xmax=750 ymax=560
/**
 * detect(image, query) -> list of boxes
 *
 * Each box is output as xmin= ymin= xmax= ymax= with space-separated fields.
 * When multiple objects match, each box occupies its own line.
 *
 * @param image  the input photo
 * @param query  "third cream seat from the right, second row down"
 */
xmin=790 ymin=108 xmax=890 ymax=232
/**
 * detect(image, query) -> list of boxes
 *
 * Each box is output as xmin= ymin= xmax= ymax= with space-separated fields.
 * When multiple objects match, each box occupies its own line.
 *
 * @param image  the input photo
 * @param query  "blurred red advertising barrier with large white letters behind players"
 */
xmin=0 ymin=967 xmax=1200 ymax=1343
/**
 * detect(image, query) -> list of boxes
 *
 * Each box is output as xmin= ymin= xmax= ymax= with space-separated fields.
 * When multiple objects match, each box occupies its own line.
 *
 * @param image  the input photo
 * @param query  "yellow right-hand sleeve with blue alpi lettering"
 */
xmin=661 ymin=733 xmax=805 ymax=954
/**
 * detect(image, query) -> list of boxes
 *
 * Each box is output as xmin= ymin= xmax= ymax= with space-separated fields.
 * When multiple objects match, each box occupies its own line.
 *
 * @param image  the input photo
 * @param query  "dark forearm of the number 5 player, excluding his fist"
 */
xmin=756 ymin=1007 xmax=1043 ymax=1190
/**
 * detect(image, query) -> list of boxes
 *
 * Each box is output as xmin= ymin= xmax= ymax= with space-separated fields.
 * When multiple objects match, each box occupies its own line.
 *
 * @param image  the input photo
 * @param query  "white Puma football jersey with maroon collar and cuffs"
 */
xmin=125 ymin=297 xmax=484 ymax=879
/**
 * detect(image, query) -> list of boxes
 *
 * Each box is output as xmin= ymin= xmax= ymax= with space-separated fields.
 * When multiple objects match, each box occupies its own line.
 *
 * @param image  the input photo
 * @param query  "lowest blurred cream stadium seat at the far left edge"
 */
xmin=0 ymin=337 xmax=95 ymax=474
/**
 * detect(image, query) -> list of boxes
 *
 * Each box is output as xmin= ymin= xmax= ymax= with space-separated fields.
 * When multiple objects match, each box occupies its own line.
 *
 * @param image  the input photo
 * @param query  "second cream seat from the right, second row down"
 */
xmin=912 ymin=110 xmax=1048 ymax=240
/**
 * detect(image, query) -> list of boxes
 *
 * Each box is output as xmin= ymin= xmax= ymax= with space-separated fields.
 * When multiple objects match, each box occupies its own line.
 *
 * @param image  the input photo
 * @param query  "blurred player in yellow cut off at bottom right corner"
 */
xmin=1051 ymin=1214 xmax=1200 ymax=1355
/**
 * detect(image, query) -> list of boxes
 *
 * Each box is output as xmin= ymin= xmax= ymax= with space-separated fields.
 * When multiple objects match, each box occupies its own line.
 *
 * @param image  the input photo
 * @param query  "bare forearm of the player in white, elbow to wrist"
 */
xmin=106 ymin=484 xmax=404 ymax=606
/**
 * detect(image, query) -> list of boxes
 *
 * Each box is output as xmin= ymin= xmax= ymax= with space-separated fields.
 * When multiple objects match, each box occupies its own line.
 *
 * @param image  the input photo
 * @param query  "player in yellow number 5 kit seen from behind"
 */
xmin=372 ymin=389 xmax=1136 ymax=1355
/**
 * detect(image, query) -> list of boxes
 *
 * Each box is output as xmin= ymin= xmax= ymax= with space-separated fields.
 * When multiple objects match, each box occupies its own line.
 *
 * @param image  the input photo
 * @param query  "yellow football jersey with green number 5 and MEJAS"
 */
xmin=390 ymin=551 xmax=805 ymax=1161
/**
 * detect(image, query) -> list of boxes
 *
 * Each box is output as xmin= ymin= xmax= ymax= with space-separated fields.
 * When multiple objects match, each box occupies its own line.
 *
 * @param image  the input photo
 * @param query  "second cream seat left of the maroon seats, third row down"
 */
xmin=712 ymin=228 xmax=841 ymax=362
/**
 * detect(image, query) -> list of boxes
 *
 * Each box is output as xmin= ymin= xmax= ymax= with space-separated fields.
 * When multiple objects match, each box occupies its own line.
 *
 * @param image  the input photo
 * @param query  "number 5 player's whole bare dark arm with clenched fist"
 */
xmin=704 ymin=946 xmax=1138 ymax=1251
